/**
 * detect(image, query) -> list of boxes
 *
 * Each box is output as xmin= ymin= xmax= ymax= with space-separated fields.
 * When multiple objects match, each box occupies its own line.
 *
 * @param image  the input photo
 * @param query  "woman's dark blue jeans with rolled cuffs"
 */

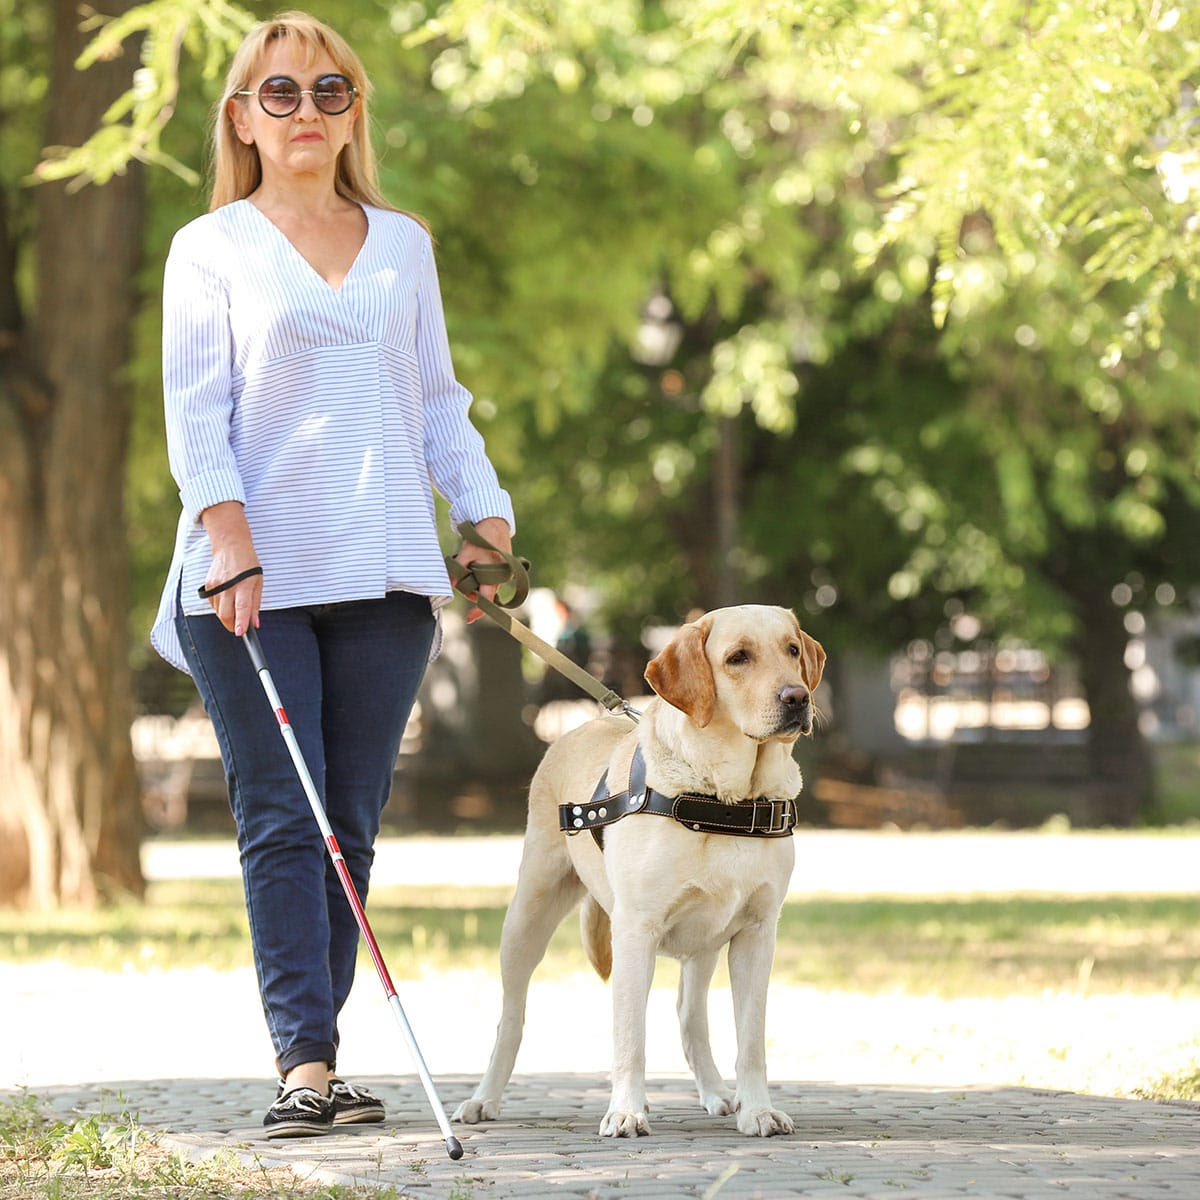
xmin=175 ymin=592 xmax=434 ymax=1075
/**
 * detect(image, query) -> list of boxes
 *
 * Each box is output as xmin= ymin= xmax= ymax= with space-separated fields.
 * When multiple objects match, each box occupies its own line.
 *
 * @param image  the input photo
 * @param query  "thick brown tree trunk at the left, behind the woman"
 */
xmin=0 ymin=0 xmax=144 ymax=907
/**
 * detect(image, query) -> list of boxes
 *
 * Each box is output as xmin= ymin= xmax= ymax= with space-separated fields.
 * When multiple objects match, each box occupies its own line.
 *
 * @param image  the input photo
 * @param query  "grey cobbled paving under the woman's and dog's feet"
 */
xmin=23 ymin=1074 xmax=1200 ymax=1200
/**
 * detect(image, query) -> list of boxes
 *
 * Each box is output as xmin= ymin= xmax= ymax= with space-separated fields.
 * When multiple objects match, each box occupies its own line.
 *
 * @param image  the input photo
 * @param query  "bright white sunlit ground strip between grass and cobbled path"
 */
xmin=0 ymin=964 xmax=1200 ymax=1094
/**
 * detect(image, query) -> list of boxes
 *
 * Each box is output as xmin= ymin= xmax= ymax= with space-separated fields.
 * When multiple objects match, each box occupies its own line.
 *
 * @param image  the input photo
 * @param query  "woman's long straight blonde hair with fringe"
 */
xmin=209 ymin=12 xmax=428 ymax=229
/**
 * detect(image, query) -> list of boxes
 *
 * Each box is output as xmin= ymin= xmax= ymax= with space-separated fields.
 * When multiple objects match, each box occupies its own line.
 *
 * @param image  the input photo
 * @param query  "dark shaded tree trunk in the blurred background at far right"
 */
xmin=1074 ymin=587 xmax=1154 ymax=826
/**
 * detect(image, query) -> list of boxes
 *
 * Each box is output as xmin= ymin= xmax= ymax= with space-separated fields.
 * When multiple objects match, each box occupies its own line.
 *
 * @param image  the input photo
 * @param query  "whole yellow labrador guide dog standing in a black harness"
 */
xmin=454 ymin=605 xmax=826 ymax=1138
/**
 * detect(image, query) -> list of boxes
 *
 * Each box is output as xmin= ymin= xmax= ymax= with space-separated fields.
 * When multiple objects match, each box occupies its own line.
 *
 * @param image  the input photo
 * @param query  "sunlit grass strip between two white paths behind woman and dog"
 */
xmin=0 ymin=880 xmax=1200 ymax=996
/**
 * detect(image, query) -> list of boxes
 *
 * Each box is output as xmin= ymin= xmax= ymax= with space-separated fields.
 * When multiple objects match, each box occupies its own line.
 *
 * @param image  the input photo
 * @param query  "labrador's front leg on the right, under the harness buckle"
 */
xmin=730 ymin=920 xmax=796 ymax=1138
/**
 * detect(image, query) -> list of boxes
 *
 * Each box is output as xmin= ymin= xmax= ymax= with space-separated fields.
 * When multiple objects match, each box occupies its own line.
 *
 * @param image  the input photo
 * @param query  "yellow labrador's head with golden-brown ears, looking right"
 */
xmin=646 ymin=605 xmax=826 ymax=742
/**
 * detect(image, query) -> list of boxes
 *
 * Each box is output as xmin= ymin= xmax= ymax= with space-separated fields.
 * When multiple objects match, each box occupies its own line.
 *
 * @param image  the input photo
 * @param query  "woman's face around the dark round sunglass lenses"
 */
xmin=228 ymin=37 xmax=359 ymax=182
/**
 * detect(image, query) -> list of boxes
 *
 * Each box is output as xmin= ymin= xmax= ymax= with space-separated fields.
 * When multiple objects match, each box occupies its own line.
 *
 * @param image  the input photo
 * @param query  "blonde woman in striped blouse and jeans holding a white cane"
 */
xmin=152 ymin=13 xmax=514 ymax=1138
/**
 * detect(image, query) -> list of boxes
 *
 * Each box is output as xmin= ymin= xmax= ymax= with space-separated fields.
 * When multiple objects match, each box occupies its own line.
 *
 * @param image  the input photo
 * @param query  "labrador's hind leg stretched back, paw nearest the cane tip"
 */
xmin=454 ymin=853 xmax=583 ymax=1124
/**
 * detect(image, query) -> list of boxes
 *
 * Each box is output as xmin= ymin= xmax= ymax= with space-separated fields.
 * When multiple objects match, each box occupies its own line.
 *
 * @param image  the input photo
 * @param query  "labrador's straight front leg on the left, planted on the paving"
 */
xmin=600 ymin=910 xmax=658 ymax=1138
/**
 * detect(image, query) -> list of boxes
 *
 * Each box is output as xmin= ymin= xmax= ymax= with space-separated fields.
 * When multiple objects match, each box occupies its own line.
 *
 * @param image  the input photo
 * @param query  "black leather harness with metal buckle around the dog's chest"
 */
xmin=558 ymin=745 xmax=797 ymax=850
